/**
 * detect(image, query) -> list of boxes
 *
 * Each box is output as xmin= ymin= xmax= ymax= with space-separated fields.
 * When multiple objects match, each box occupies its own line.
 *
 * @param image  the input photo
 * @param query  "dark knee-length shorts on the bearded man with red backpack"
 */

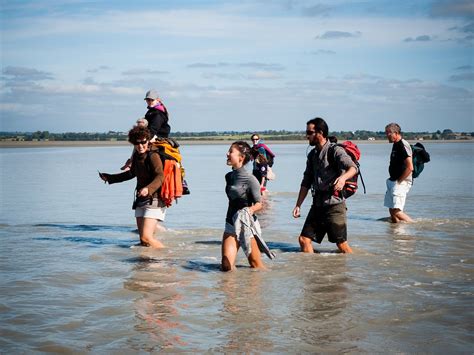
xmin=300 ymin=202 xmax=347 ymax=244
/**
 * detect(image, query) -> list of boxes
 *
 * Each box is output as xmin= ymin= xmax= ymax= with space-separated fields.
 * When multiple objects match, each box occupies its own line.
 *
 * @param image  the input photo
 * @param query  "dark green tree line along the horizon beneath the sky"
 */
xmin=0 ymin=129 xmax=474 ymax=141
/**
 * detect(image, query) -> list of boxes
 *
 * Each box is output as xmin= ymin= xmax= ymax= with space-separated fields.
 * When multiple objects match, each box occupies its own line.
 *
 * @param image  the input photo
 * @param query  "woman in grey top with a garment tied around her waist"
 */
xmin=222 ymin=141 xmax=265 ymax=271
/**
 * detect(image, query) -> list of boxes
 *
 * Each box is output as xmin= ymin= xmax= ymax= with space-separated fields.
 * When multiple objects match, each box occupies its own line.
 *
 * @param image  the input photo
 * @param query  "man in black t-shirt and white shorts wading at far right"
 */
xmin=384 ymin=123 xmax=413 ymax=223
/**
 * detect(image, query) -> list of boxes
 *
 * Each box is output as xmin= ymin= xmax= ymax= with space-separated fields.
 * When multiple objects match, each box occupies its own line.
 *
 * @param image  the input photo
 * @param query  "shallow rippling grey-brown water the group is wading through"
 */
xmin=0 ymin=143 xmax=474 ymax=353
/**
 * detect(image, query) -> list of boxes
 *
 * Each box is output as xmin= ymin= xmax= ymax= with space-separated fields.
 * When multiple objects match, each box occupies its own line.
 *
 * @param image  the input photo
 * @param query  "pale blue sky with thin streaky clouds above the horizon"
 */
xmin=0 ymin=0 xmax=474 ymax=133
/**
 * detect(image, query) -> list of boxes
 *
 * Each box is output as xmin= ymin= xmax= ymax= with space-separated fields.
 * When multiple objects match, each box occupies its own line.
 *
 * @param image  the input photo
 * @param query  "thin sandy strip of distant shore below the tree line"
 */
xmin=0 ymin=139 xmax=474 ymax=148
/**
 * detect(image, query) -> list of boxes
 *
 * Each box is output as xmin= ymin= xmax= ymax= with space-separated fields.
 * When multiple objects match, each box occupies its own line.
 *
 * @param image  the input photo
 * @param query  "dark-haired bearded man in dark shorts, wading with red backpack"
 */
xmin=293 ymin=117 xmax=358 ymax=253
